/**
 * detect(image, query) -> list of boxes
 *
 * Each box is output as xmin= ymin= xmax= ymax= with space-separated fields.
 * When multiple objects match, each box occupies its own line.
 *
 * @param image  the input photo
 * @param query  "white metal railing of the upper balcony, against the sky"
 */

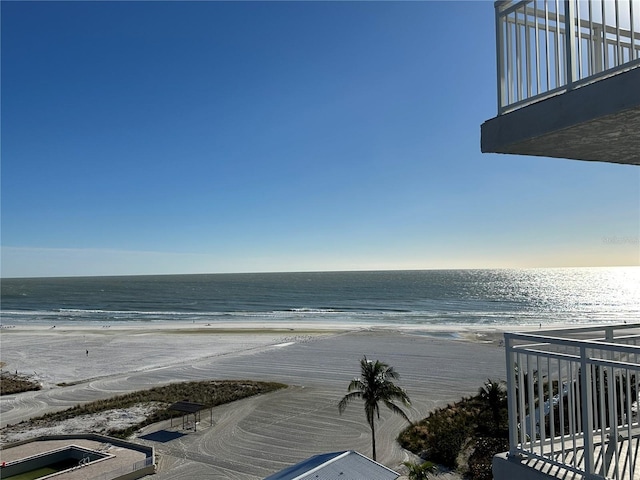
xmin=495 ymin=0 xmax=640 ymax=115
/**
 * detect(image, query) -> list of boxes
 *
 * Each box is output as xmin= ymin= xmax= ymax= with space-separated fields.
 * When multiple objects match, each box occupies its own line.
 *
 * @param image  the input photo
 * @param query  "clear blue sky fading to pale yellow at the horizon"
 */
xmin=1 ymin=1 xmax=640 ymax=277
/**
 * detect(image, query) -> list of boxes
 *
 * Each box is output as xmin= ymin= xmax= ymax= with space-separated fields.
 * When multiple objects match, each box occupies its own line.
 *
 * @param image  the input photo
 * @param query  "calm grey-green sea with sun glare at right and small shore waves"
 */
xmin=1 ymin=267 xmax=640 ymax=326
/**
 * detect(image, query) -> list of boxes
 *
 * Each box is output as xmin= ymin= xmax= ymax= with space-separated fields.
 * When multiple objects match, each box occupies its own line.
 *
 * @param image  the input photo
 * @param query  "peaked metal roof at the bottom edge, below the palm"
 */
xmin=264 ymin=450 xmax=400 ymax=480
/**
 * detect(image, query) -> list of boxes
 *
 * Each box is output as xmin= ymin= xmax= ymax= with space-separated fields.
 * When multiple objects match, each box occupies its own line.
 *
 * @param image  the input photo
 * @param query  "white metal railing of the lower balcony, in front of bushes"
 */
xmin=505 ymin=324 xmax=640 ymax=480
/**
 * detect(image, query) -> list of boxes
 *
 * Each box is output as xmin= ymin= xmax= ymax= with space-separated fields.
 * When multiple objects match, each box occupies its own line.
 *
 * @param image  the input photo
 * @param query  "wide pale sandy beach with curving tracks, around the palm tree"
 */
xmin=0 ymin=323 xmax=505 ymax=480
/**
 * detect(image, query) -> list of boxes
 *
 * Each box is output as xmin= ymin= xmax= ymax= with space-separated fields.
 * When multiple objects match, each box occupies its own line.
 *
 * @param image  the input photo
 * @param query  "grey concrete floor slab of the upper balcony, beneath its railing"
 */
xmin=481 ymin=68 xmax=640 ymax=165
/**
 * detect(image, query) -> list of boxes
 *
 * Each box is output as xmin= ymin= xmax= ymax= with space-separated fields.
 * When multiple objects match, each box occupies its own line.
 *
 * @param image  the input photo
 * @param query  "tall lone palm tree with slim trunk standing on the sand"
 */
xmin=338 ymin=356 xmax=411 ymax=460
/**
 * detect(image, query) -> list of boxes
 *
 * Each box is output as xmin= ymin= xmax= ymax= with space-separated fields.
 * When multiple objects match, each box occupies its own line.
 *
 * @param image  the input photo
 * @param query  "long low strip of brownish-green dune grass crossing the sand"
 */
xmin=1 ymin=380 xmax=286 ymax=438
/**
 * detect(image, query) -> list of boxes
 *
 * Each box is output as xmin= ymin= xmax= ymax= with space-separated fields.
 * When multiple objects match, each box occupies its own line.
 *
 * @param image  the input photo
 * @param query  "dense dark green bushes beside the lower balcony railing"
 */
xmin=398 ymin=380 xmax=509 ymax=480
